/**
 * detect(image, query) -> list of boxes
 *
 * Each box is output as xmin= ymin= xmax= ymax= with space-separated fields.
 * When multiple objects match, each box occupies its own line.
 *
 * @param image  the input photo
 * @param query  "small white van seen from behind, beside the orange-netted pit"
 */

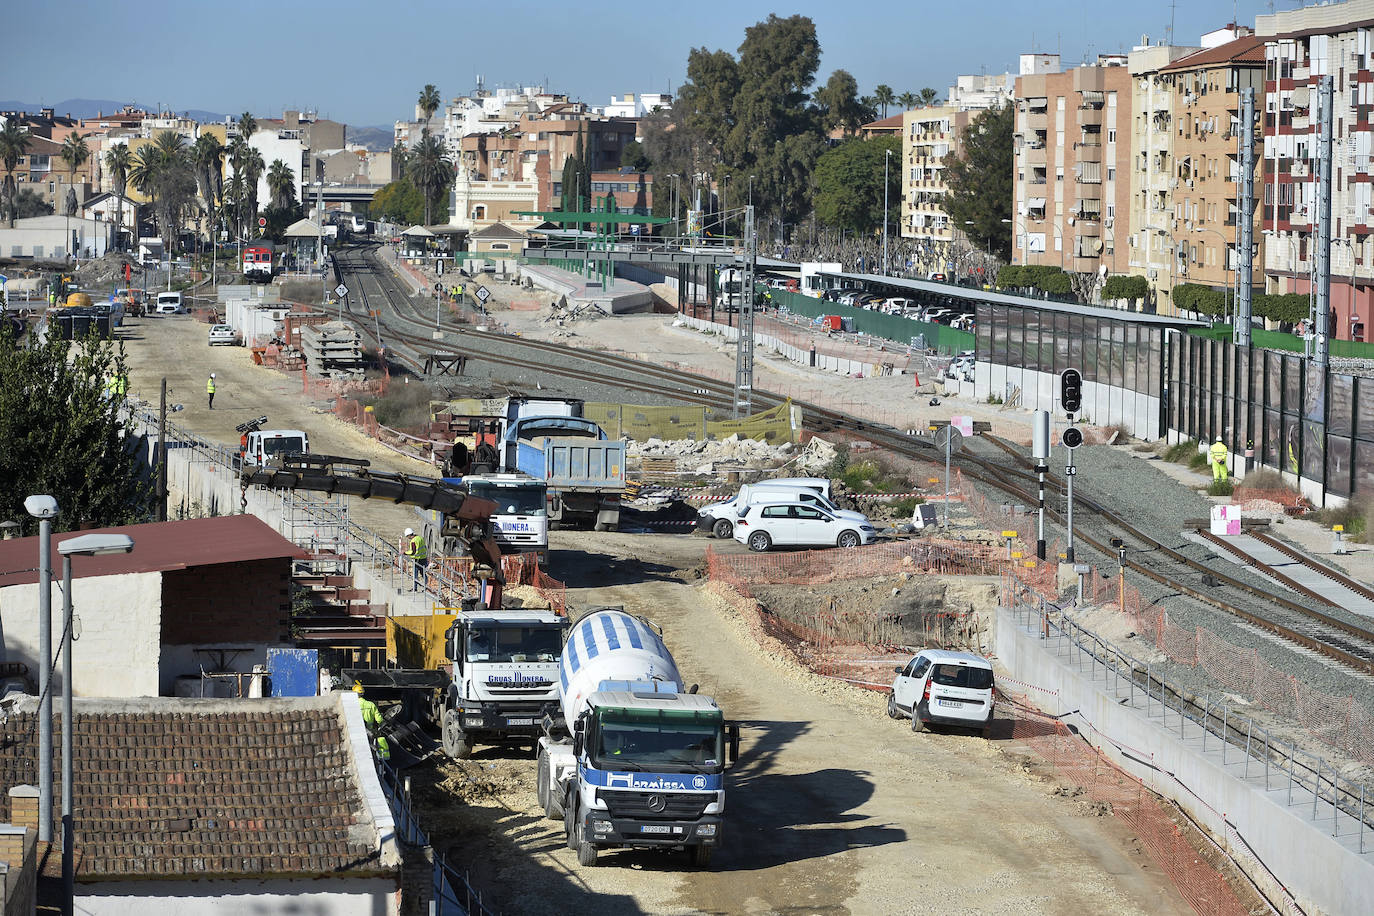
xmin=888 ymin=648 xmax=998 ymax=737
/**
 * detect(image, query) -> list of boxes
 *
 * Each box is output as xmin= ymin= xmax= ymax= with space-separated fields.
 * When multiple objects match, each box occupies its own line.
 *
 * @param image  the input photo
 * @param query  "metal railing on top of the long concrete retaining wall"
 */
xmin=1011 ymin=589 xmax=1374 ymax=854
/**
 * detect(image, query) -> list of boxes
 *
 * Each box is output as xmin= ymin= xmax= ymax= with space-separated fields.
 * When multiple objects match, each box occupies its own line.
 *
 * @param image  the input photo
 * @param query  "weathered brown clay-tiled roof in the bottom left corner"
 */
xmin=0 ymin=700 xmax=386 ymax=880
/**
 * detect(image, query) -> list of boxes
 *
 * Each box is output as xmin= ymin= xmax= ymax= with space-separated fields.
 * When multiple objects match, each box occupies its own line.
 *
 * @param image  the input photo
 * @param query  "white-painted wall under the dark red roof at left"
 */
xmin=0 ymin=574 xmax=162 ymax=696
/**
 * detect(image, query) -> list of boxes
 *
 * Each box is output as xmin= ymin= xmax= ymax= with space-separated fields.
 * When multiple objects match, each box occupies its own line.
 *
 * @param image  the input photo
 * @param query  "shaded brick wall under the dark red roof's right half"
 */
xmin=162 ymin=558 xmax=291 ymax=645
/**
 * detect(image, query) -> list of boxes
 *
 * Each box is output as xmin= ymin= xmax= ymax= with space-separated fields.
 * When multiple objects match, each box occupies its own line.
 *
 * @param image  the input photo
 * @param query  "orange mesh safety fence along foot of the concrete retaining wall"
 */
xmin=993 ymin=688 xmax=1250 ymax=916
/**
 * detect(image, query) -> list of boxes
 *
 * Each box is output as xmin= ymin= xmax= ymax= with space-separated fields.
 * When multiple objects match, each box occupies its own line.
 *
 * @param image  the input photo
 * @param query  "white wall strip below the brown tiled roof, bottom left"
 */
xmin=76 ymin=878 xmax=398 ymax=916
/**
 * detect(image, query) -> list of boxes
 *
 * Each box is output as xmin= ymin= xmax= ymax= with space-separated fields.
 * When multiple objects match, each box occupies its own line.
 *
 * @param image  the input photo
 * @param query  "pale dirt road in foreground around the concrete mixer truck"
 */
xmin=414 ymin=534 xmax=1191 ymax=913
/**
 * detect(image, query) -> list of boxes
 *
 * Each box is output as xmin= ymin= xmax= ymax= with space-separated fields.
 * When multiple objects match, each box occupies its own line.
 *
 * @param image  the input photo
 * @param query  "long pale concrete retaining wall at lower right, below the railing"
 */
xmin=996 ymin=608 xmax=1374 ymax=913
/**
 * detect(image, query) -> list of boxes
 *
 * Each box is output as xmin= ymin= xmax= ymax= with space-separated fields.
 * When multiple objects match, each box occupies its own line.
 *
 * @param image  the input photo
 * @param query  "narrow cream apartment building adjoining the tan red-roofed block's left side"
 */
xmin=1120 ymin=37 xmax=1202 ymax=307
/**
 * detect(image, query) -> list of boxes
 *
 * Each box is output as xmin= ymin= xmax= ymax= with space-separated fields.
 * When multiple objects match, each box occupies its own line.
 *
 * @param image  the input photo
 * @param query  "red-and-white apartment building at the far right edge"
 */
xmin=1254 ymin=0 xmax=1374 ymax=341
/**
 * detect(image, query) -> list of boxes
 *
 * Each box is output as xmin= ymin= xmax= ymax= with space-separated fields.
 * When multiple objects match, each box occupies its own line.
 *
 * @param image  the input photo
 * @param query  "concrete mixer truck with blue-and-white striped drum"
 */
xmin=536 ymin=607 xmax=739 ymax=867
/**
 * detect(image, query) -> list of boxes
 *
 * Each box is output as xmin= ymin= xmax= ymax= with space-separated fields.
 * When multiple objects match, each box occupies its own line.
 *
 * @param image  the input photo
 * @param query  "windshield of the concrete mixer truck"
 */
xmin=594 ymin=710 xmax=724 ymax=770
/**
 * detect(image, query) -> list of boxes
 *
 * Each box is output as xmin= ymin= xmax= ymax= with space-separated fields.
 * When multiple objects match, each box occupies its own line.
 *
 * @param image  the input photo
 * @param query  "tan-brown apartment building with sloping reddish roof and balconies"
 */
xmin=1160 ymin=36 xmax=1264 ymax=314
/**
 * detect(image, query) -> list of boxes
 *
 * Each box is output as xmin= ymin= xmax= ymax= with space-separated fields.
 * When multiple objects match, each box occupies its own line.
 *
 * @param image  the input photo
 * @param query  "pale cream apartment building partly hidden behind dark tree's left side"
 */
xmin=894 ymin=104 xmax=976 ymax=248
